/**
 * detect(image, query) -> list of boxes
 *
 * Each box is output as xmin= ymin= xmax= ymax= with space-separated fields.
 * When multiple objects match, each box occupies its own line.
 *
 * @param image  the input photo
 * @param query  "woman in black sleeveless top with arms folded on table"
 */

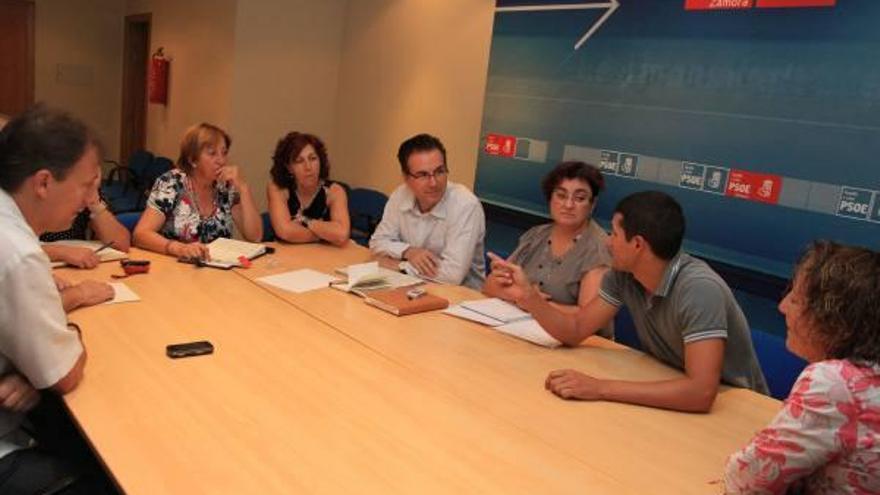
xmin=267 ymin=132 xmax=350 ymax=246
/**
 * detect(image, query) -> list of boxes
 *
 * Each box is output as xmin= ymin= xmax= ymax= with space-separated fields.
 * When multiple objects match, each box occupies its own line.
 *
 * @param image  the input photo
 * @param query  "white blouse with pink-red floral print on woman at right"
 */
xmin=724 ymin=360 xmax=880 ymax=495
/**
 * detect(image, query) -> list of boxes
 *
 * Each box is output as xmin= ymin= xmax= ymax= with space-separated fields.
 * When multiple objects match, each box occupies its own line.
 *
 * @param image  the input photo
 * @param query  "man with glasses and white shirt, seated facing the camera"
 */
xmin=370 ymin=134 xmax=486 ymax=290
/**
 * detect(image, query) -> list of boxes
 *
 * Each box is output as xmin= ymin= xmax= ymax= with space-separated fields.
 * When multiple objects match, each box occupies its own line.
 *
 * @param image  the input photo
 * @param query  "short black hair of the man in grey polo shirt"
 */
xmin=614 ymin=191 xmax=685 ymax=260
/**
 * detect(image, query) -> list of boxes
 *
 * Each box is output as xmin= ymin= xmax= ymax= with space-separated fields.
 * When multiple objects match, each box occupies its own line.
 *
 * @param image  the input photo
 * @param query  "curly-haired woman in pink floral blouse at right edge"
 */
xmin=724 ymin=241 xmax=880 ymax=495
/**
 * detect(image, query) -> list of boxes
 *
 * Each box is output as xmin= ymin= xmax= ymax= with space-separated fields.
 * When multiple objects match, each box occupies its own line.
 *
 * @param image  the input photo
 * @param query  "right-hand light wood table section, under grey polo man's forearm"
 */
xmin=237 ymin=243 xmax=780 ymax=495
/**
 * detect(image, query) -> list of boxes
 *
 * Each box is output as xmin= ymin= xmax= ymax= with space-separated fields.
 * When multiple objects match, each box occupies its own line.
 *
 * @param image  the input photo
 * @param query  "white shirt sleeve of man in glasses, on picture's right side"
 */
xmin=436 ymin=196 xmax=486 ymax=285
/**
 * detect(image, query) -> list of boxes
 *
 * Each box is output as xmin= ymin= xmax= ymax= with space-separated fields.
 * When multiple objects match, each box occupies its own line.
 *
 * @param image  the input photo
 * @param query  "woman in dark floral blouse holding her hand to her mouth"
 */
xmin=133 ymin=123 xmax=263 ymax=259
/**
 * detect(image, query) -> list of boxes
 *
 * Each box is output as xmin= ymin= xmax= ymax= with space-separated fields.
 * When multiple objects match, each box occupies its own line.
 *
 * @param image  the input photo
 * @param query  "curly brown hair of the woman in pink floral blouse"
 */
xmin=795 ymin=241 xmax=880 ymax=363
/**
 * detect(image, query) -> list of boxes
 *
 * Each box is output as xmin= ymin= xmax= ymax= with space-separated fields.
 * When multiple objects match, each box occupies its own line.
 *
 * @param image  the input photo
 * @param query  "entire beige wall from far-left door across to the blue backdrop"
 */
xmin=36 ymin=0 xmax=494 ymax=203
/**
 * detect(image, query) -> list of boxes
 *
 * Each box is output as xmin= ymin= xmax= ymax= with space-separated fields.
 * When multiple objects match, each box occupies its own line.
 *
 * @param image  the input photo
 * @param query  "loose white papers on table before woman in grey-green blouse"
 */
xmin=444 ymin=297 xmax=562 ymax=347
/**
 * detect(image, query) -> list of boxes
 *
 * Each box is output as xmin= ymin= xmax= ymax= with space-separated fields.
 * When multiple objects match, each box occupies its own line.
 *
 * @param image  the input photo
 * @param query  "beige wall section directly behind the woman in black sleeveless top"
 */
xmin=231 ymin=0 xmax=347 ymax=210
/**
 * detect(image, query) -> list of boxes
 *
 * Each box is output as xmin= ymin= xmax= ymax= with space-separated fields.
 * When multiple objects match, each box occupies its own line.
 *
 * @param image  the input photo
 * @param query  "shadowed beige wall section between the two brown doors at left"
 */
xmin=34 ymin=0 xmax=125 ymax=160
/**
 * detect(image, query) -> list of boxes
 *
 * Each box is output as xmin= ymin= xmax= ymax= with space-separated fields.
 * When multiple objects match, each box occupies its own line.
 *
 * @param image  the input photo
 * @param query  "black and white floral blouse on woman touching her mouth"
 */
xmin=147 ymin=169 xmax=238 ymax=244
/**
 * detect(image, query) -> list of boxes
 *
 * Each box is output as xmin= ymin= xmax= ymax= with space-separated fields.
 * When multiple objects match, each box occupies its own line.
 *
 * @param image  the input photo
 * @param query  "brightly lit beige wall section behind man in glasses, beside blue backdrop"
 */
xmin=334 ymin=0 xmax=495 ymax=192
